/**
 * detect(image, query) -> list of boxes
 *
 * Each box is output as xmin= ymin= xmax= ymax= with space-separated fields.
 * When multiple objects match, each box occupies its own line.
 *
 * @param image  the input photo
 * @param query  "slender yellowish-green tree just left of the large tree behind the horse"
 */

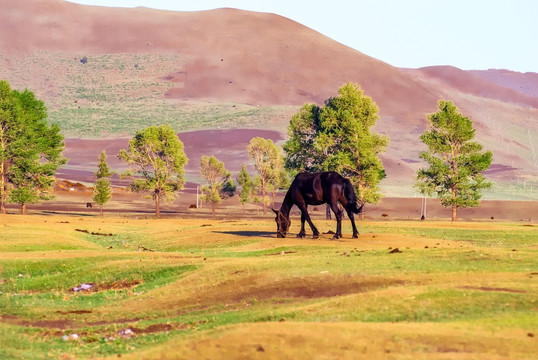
xmin=248 ymin=137 xmax=283 ymax=214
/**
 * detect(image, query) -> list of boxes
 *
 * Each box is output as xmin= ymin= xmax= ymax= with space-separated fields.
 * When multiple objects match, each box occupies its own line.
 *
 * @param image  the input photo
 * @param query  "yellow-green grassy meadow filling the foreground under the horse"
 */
xmin=0 ymin=215 xmax=538 ymax=359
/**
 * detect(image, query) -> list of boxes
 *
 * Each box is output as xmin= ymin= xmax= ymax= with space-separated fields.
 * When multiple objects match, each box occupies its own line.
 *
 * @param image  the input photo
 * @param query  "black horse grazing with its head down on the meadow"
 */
xmin=273 ymin=171 xmax=364 ymax=239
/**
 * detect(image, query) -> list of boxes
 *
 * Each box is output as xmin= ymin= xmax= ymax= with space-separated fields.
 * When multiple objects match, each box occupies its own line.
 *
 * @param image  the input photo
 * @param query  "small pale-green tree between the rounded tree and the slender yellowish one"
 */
xmin=200 ymin=156 xmax=235 ymax=215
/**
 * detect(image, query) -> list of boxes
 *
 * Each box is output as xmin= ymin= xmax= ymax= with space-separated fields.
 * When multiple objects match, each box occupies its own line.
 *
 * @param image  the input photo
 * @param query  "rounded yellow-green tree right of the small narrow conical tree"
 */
xmin=118 ymin=125 xmax=188 ymax=217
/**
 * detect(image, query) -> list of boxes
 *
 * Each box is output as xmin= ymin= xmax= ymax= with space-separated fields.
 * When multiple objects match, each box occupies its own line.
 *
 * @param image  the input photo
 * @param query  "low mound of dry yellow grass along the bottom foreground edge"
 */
xmin=112 ymin=322 xmax=537 ymax=360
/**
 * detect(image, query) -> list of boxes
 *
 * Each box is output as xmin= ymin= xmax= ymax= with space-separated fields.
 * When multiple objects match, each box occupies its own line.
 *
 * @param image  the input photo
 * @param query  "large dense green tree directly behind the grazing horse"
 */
xmin=283 ymin=83 xmax=389 ymax=203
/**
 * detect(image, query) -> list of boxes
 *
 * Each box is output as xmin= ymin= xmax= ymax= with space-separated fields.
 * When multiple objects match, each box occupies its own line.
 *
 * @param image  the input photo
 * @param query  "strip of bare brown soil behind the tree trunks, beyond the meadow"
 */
xmin=8 ymin=185 xmax=538 ymax=223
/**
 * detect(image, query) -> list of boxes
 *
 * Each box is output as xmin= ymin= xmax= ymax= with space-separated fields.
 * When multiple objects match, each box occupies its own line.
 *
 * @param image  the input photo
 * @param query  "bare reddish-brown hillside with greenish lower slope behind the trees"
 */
xmin=0 ymin=0 xmax=538 ymax=200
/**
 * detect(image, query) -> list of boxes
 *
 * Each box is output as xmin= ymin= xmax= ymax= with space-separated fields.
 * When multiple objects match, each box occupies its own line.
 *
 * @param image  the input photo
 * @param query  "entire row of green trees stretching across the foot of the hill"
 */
xmin=0 ymin=81 xmax=492 ymax=221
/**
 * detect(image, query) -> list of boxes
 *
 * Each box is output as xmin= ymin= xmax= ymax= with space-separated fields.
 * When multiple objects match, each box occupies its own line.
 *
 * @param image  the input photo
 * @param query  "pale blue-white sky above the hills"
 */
xmin=69 ymin=0 xmax=538 ymax=73
